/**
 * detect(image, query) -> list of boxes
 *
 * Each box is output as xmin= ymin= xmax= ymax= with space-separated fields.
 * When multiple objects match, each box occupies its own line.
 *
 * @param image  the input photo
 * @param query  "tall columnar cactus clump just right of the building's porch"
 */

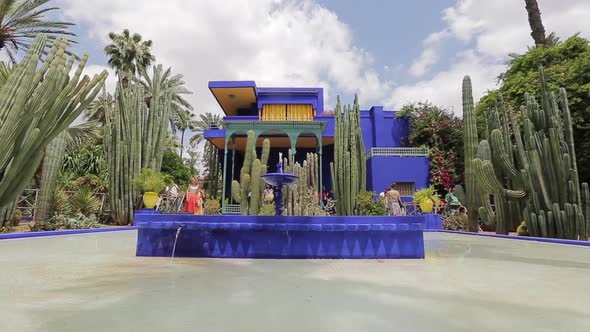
xmin=330 ymin=96 xmax=367 ymax=215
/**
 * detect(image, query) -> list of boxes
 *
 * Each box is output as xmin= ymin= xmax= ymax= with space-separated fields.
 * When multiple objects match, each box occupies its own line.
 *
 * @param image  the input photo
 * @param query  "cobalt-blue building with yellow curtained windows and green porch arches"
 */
xmin=204 ymin=81 xmax=429 ymax=213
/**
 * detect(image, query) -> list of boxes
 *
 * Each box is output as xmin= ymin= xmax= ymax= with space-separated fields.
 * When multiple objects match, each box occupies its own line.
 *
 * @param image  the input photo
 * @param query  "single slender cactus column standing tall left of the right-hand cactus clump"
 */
xmin=463 ymin=76 xmax=479 ymax=232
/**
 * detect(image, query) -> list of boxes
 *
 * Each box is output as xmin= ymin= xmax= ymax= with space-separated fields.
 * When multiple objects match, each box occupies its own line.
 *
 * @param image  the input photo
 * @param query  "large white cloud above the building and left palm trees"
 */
xmin=62 ymin=0 xmax=393 ymax=113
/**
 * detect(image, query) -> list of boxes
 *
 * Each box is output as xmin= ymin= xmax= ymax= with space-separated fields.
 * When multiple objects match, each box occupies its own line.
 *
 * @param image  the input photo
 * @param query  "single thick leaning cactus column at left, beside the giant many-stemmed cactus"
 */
xmin=35 ymin=131 xmax=67 ymax=222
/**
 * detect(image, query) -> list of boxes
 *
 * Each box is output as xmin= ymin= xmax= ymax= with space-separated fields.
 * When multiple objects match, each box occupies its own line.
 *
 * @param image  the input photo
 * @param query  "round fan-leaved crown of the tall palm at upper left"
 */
xmin=104 ymin=29 xmax=156 ymax=84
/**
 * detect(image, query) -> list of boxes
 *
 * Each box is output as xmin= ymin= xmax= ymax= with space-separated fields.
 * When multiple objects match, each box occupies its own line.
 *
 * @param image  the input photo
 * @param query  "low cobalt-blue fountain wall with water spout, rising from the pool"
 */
xmin=135 ymin=210 xmax=440 ymax=259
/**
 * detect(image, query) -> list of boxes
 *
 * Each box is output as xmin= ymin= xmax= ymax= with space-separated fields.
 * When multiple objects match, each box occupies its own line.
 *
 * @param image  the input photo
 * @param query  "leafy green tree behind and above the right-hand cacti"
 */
xmin=476 ymin=36 xmax=590 ymax=182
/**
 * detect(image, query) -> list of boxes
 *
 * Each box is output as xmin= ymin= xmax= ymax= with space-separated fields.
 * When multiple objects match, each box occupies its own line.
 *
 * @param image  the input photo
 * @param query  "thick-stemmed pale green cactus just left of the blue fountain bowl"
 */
xmin=231 ymin=130 xmax=270 ymax=215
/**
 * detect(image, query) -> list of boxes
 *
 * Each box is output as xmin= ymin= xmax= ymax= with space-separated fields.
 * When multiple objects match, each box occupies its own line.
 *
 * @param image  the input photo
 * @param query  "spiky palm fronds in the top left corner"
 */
xmin=0 ymin=0 xmax=75 ymax=63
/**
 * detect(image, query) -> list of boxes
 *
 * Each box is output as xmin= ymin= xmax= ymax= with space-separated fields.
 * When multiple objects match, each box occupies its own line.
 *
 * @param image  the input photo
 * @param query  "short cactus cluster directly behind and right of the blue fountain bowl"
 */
xmin=283 ymin=149 xmax=324 ymax=216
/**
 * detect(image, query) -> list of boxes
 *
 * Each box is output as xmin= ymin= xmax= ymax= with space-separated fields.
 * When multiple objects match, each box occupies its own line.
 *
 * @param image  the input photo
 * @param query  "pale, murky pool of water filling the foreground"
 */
xmin=0 ymin=231 xmax=590 ymax=332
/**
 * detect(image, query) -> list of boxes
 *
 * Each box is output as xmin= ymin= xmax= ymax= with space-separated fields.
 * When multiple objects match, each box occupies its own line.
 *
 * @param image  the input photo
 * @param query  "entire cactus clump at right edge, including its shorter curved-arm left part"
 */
xmin=471 ymin=68 xmax=590 ymax=240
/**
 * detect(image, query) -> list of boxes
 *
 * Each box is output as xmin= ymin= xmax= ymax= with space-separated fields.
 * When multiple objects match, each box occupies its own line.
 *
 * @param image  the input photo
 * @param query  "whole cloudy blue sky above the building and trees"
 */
xmin=47 ymin=0 xmax=590 ymax=115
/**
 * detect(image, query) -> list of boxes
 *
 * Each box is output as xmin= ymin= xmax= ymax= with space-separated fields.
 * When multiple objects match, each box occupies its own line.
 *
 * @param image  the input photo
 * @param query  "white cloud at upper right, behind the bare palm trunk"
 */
xmin=386 ymin=0 xmax=590 ymax=114
